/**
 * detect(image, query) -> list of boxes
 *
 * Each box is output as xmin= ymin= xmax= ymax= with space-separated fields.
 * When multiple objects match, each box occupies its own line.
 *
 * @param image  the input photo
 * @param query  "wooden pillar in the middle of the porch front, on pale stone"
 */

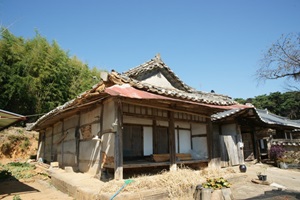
xmin=168 ymin=111 xmax=177 ymax=171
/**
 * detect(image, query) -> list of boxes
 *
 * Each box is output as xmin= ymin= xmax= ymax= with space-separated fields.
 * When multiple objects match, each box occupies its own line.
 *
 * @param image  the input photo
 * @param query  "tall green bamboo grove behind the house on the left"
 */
xmin=0 ymin=29 xmax=104 ymax=121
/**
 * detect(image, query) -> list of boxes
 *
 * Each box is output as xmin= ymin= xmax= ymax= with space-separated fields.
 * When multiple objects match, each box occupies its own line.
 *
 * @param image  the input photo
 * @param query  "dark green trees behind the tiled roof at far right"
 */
xmin=235 ymin=91 xmax=300 ymax=119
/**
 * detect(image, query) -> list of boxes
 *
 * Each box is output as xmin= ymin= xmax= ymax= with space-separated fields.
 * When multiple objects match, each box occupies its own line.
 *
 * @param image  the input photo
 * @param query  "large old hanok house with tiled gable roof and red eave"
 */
xmin=32 ymin=56 xmax=246 ymax=179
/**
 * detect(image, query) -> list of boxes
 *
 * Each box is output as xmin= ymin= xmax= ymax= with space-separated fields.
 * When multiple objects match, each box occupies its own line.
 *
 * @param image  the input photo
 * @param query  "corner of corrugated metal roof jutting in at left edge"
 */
xmin=0 ymin=109 xmax=26 ymax=131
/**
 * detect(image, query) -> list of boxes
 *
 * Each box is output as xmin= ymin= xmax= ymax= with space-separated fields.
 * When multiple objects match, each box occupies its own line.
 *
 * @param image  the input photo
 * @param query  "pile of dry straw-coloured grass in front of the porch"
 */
xmin=100 ymin=168 xmax=236 ymax=199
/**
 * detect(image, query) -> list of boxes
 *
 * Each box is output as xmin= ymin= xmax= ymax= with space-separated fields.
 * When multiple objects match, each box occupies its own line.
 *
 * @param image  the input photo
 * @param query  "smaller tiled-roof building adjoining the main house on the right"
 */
xmin=212 ymin=107 xmax=300 ymax=166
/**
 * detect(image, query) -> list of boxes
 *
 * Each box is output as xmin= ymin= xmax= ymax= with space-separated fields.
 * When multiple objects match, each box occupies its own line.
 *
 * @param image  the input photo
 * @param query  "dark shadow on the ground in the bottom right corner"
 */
xmin=248 ymin=190 xmax=300 ymax=200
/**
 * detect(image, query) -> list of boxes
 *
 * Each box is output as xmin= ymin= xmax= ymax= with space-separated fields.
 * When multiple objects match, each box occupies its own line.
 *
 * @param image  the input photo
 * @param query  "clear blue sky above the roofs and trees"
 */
xmin=0 ymin=0 xmax=300 ymax=99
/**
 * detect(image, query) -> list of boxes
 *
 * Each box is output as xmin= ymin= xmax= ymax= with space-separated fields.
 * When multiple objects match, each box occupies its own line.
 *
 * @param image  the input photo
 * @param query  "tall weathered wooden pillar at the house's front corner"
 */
xmin=114 ymin=99 xmax=123 ymax=180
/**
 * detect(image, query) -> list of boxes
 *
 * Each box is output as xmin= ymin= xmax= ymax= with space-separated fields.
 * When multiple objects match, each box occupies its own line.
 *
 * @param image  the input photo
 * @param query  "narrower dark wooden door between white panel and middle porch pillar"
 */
xmin=153 ymin=127 xmax=169 ymax=154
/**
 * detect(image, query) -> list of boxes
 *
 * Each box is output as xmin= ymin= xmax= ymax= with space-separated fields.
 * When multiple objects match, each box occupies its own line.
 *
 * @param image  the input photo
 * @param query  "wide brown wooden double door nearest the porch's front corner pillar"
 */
xmin=123 ymin=125 xmax=143 ymax=160
